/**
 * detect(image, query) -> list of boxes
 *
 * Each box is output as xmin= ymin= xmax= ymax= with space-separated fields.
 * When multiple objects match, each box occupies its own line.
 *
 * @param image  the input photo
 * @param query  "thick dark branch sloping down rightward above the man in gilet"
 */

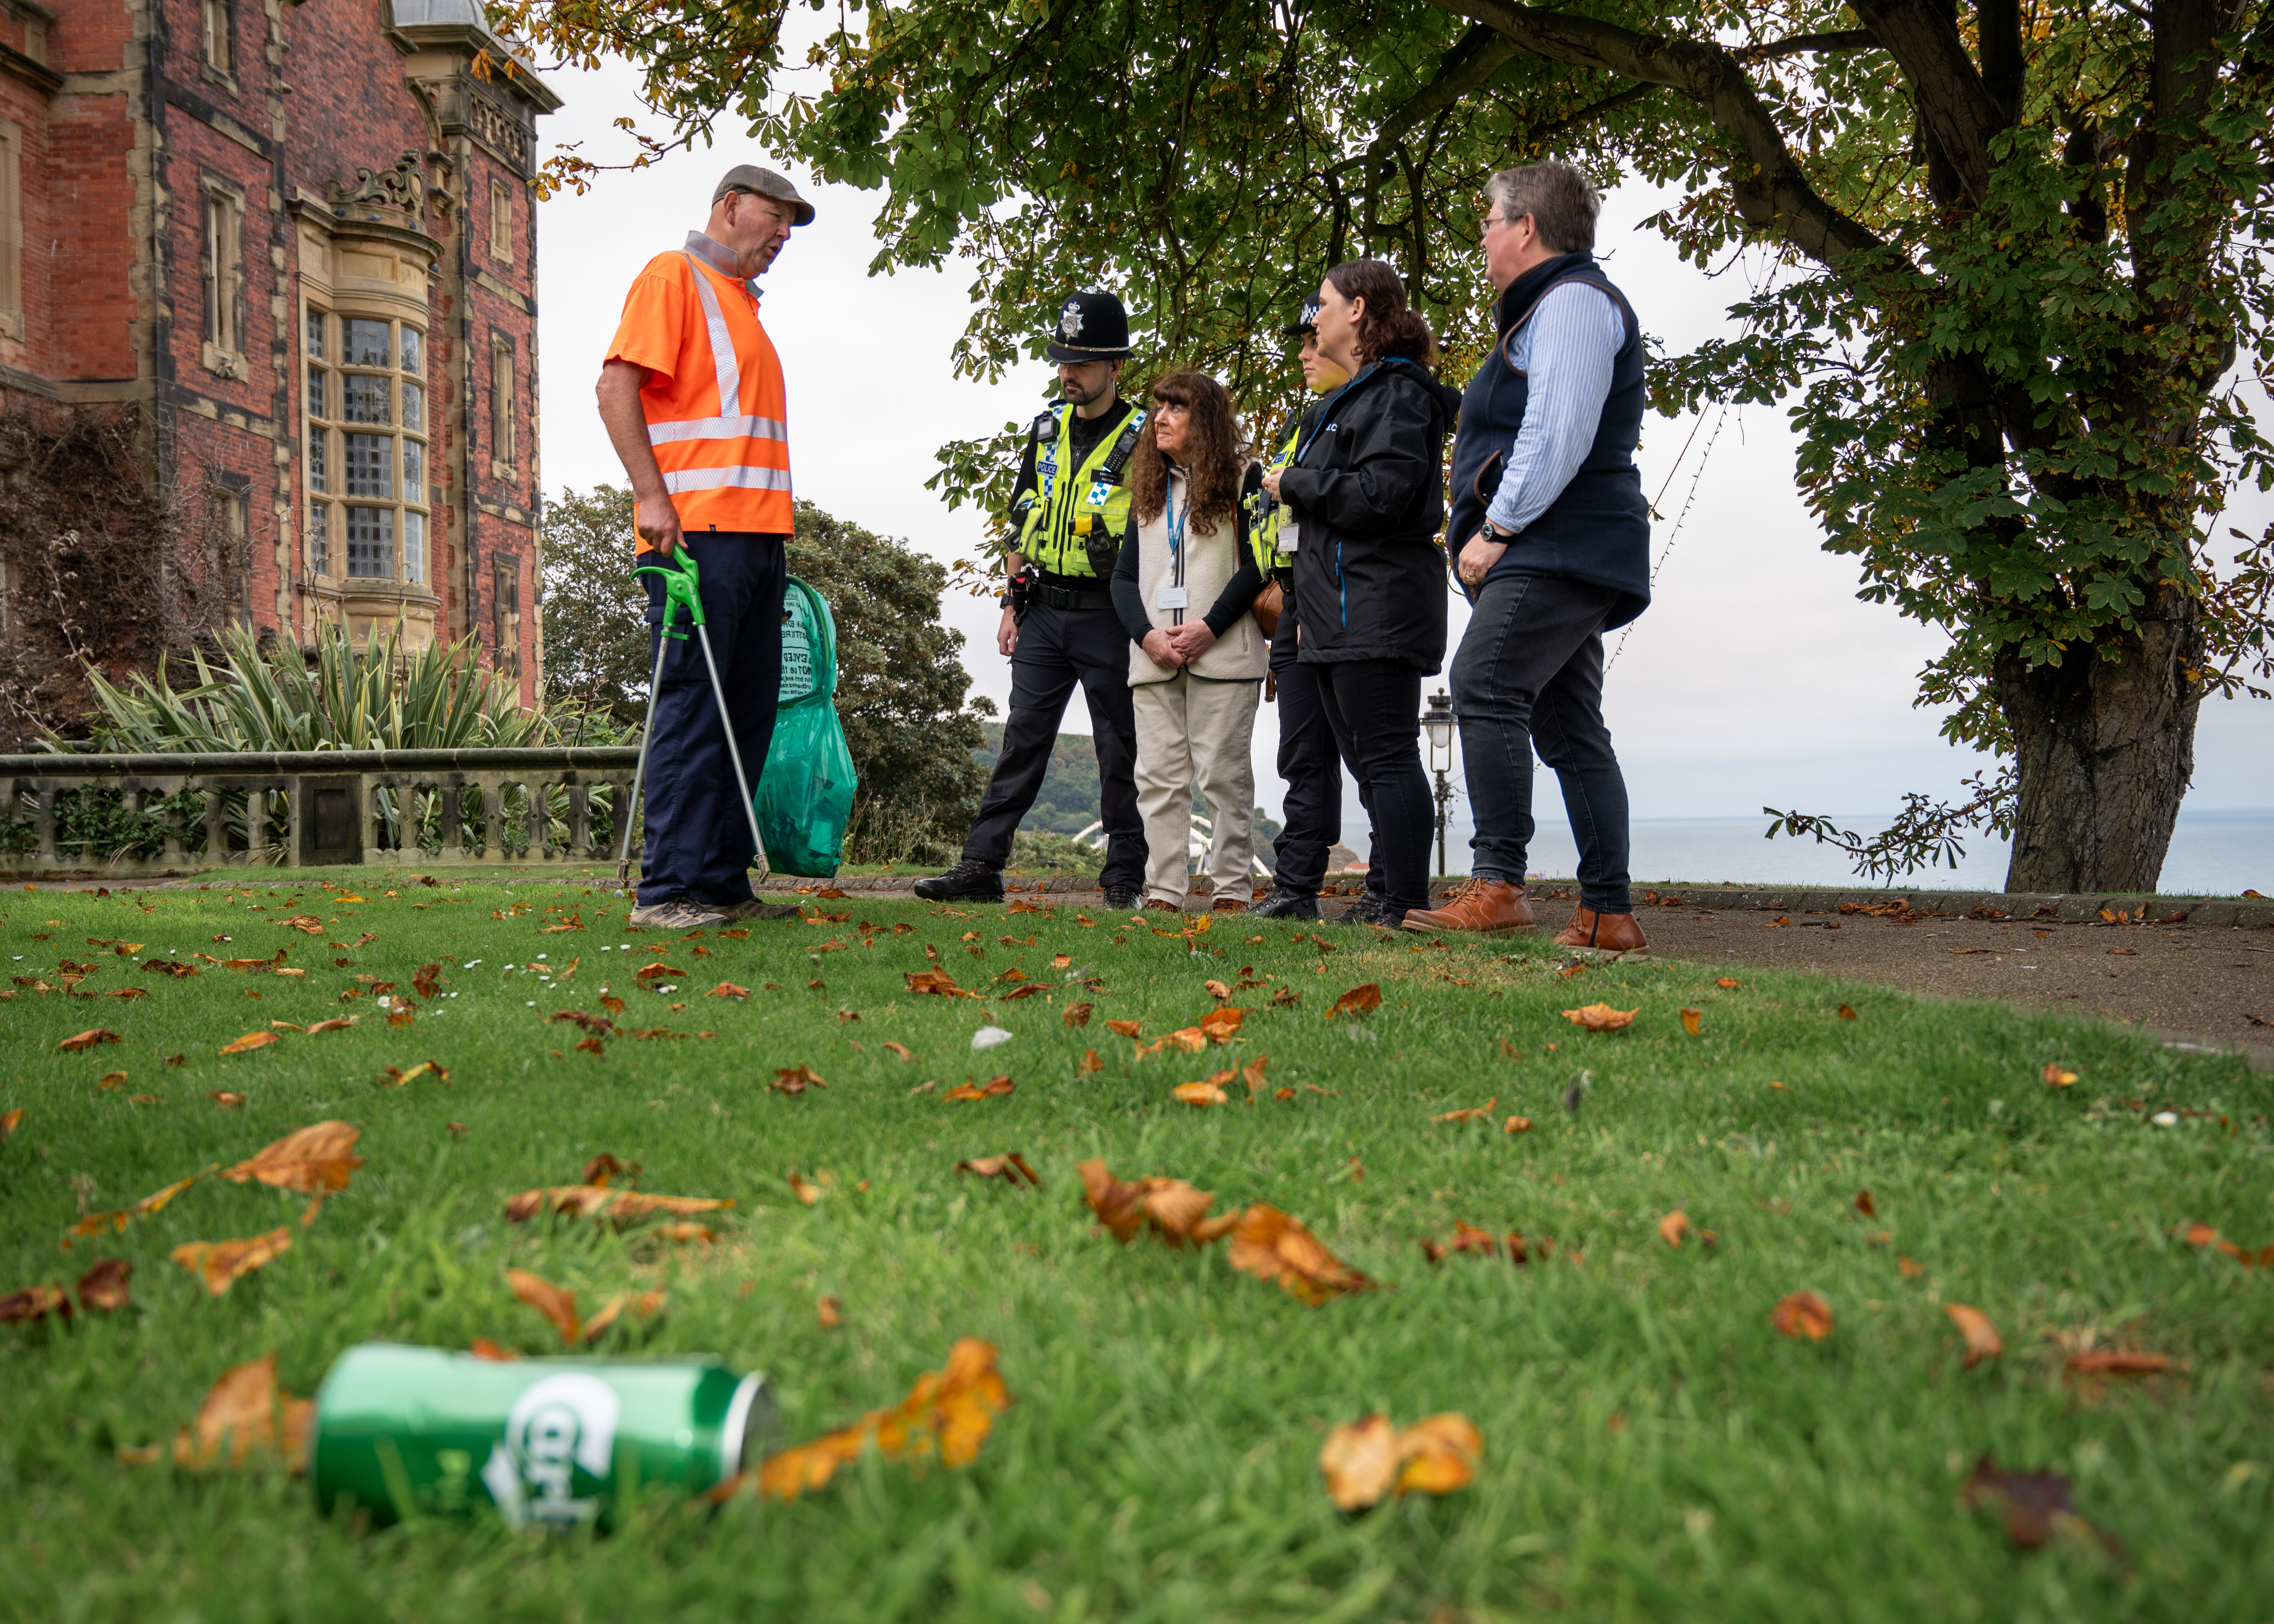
xmin=1430 ymin=0 xmax=1885 ymax=271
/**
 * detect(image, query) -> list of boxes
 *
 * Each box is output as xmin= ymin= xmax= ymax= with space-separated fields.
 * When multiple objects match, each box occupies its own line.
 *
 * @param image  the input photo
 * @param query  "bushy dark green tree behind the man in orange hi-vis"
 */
xmin=543 ymin=485 xmax=994 ymax=862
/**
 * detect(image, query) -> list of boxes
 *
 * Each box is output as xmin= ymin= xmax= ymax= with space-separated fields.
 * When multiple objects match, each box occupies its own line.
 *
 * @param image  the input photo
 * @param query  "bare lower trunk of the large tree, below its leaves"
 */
xmin=1994 ymin=587 xmax=2203 ymax=892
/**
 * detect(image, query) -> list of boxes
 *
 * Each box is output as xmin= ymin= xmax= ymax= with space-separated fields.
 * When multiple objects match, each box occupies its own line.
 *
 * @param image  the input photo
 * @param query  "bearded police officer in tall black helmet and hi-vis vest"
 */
xmin=916 ymin=293 xmax=1146 ymax=908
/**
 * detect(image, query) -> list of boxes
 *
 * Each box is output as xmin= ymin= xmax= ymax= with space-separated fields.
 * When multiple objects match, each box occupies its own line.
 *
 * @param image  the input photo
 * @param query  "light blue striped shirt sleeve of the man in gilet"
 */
xmin=1460 ymin=282 xmax=1626 ymax=532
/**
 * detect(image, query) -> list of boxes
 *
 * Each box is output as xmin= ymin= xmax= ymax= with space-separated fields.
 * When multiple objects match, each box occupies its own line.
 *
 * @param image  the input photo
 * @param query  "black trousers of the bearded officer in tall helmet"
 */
xmin=964 ymin=603 xmax=1146 ymax=892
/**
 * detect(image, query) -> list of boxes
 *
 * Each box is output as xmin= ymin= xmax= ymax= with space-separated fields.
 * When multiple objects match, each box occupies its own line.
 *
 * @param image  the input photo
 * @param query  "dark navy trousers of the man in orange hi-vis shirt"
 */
xmin=639 ymin=530 xmax=789 ymax=908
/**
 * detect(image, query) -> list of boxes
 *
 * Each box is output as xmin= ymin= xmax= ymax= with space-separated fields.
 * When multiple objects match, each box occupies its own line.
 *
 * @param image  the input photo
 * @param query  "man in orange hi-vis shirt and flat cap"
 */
xmin=600 ymin=164 xmax=814 ymax=930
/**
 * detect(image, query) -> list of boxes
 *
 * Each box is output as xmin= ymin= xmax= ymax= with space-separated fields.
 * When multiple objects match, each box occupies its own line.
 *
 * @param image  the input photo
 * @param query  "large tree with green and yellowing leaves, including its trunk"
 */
xmin=500 ymin=0 xmax=2274 ymax=890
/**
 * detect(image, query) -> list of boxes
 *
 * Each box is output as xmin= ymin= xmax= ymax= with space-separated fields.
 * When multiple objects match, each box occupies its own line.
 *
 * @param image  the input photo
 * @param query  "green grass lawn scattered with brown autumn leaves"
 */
xmin=0 ymin=880 xmax=2274 ymax=1624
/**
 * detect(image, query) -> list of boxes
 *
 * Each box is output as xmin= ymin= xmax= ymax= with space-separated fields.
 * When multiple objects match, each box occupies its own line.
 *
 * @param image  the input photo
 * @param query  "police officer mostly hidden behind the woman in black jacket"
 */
xmin=1249 ymin=293 xmax=1380 ymax=919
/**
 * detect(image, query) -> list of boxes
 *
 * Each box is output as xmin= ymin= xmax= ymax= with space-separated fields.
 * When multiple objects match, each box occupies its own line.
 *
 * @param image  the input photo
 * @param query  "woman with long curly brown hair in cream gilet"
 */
xmin=1112 ymin=373 xmax=1271 ymax=912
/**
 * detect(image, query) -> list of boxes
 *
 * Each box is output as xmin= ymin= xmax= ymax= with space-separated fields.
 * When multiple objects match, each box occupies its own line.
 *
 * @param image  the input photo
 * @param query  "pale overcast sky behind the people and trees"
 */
xmin=539 ymin=52 xmax=2274 ymax=841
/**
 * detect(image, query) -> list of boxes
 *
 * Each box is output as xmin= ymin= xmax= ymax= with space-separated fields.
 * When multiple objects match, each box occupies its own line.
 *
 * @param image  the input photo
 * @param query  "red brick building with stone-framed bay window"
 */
xmin=0 ymin=0 xmax=559 ymax=703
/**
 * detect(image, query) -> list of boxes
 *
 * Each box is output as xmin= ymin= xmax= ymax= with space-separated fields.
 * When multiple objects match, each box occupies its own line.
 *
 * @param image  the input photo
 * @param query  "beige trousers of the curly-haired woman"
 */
xmin=1130 ymin=671 xmax=1262 ymax=908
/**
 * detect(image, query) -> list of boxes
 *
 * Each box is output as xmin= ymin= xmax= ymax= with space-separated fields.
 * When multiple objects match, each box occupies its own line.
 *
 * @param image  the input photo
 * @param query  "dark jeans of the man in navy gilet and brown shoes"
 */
xmin=1453 ymin=576 xmax=1633 ymax=915
